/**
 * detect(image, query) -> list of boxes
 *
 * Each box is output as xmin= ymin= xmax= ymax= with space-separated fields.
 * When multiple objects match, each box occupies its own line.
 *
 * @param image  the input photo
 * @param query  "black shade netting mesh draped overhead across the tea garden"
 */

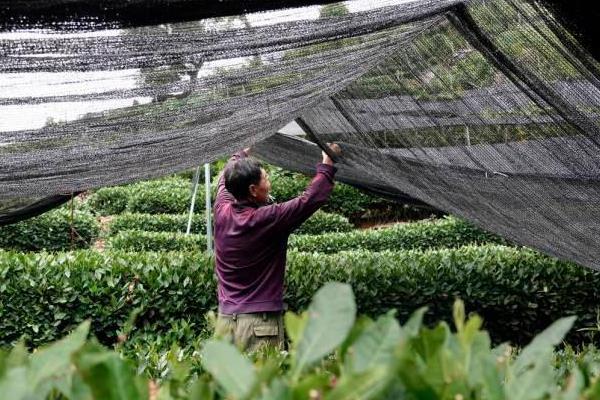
xmin=0 ymin=0 xmax=600 ymax=269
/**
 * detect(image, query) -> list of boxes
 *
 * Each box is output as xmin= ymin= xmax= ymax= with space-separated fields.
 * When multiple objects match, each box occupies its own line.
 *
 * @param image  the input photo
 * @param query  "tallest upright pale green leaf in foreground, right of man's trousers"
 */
xmin=294 ymin=282 xmax=356 ymax=375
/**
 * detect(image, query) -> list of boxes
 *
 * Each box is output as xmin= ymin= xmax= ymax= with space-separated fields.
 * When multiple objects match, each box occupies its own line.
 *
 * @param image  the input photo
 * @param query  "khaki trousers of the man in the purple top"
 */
xmin=215 ymin=312 xmax=284 ymax=352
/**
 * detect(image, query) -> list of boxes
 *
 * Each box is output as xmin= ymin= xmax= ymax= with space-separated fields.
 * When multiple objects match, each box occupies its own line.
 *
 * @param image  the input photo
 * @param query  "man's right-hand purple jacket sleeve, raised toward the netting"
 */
xmin=257 ymin=164 xmax=336 ymax=234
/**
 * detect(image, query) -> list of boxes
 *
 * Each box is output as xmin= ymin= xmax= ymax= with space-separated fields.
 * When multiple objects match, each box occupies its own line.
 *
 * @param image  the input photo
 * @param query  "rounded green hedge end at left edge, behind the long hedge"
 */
xmin=0 ymin=207 xmax=100 ymax=251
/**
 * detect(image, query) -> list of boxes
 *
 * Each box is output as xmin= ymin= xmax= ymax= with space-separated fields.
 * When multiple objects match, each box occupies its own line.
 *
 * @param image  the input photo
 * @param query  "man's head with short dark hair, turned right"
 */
xmin=224 ymin=157 xmax=271 ymax=204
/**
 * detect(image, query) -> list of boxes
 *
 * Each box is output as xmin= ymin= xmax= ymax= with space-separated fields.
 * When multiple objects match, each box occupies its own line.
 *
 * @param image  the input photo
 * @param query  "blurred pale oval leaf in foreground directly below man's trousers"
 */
xmin=202 ymin=340 xmax=256 ymax=399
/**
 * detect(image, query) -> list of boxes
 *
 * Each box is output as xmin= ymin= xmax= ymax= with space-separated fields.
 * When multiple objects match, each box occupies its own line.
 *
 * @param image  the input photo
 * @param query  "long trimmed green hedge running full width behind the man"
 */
xmin=0 ymin=246 xmax=600 ymax=344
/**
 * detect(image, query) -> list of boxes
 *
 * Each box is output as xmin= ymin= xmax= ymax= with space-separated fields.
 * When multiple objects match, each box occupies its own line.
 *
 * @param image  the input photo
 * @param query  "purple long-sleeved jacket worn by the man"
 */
xmin=214 ymin=152 xmax=335 ymax=314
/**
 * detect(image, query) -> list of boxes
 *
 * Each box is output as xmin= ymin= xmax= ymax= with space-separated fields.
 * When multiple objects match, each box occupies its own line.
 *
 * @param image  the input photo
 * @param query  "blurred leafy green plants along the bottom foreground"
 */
xmin=0 ymin=283 xmax=600 ymax=400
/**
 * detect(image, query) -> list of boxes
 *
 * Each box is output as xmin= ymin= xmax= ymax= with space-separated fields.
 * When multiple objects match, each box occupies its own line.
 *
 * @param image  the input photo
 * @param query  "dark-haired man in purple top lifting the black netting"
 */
xmin=214 ymin=144 xmax=340 ymax=351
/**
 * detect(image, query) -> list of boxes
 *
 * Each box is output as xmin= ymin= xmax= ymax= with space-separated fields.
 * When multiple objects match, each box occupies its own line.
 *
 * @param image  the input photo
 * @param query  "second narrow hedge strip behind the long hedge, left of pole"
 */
xmin=109 ymin=213 xmax=206 ymax=235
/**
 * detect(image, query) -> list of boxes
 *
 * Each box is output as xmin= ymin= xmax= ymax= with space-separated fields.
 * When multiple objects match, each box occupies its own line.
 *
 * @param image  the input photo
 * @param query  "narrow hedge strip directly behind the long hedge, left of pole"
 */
xmin=106 ymin=231 xmax=206 ymax=251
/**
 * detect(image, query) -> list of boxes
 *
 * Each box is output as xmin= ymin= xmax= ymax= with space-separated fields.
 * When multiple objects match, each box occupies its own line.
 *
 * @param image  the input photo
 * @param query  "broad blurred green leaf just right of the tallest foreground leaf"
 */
xmin=346 ymin=315 xmax=402 ymax=373
